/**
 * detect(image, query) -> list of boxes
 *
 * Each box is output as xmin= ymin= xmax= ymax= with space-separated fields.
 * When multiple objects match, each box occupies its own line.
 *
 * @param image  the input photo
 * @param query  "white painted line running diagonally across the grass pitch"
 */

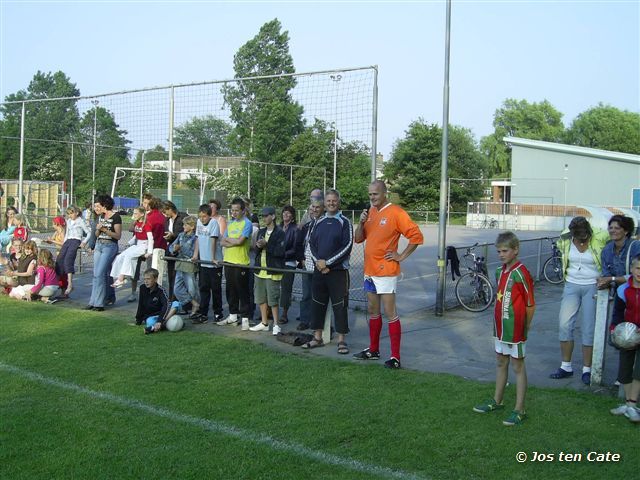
xmin=0 ymin=362 xmax=424 ymax=480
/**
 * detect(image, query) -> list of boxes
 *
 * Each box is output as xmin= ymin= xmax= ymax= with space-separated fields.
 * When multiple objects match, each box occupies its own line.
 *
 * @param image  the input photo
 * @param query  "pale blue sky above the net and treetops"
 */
xmin=0 ymin=0 xmax=640 ymax=159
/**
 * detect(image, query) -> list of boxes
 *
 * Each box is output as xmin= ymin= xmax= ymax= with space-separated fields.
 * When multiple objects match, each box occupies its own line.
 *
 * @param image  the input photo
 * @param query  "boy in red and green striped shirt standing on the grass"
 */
xmin=473 ymin=232 xmax=535 ymax=426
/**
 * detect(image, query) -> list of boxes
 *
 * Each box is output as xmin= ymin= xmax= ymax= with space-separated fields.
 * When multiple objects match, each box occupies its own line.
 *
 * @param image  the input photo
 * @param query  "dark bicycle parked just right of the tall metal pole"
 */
xmin=456 ymin=243 xmax=493 ymax=312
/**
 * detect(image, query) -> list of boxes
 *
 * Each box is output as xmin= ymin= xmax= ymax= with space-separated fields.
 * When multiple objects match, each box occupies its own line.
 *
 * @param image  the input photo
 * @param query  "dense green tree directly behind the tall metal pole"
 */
xmin=384 ymin=119 xmax=486 ymax=210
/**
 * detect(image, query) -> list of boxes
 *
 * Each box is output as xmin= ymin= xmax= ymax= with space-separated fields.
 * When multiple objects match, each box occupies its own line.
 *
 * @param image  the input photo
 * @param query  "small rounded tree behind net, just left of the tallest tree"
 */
xmin=173 ymin=115 xmax=234 ymax=157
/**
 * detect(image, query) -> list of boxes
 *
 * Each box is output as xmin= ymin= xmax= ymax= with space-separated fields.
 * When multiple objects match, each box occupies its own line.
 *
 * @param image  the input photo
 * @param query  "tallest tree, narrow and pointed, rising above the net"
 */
xmin=222 ymin=19 xmax=303 ymax=162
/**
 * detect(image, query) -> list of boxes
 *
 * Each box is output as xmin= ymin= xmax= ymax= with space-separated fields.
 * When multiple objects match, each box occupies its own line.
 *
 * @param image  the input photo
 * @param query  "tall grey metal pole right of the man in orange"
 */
xmin=435 ymin=0 xmax=451 ymax=316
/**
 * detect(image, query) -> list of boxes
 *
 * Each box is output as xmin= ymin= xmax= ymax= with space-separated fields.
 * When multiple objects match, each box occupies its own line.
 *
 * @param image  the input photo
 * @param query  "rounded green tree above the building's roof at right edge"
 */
xmin=565 ymin=103 xmax=640 ymax=155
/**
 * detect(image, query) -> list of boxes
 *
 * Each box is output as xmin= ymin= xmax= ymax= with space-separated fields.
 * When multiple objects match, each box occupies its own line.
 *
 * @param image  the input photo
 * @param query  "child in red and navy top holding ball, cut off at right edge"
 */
xmin=610 ymin=256 xmax=640 ymax=423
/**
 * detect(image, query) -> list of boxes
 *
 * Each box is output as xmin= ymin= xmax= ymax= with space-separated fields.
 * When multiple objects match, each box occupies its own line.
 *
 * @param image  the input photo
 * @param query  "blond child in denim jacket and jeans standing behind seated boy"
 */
xmin=169 ymin=217 xmax=200 ymax=314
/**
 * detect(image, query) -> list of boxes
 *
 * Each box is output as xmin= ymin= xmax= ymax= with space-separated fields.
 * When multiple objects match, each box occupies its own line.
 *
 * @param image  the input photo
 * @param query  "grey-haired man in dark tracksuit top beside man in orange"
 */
xmin=303 ymin=190 xmax=353 ymax=354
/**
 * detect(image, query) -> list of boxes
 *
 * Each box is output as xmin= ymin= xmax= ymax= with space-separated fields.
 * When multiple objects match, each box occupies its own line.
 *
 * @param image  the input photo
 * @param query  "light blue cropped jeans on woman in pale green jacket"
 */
xmin=559 ymin=282 xmax=597 ymax=347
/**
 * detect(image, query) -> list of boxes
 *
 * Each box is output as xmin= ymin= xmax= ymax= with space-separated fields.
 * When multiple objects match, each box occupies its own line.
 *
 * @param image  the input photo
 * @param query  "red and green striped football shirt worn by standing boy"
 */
xmin=493 ymin=262 xmax=535 ymax=343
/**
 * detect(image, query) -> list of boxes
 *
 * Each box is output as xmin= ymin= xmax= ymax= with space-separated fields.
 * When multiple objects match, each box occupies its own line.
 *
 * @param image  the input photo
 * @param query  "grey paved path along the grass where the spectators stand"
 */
xmin=54 ymin=262 xmax=618 ymax=392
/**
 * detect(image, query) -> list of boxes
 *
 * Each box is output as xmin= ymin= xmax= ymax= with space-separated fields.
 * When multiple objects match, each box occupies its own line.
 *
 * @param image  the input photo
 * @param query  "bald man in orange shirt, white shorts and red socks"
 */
xmin=354 ymin=180 xmax=424 ymax=368
